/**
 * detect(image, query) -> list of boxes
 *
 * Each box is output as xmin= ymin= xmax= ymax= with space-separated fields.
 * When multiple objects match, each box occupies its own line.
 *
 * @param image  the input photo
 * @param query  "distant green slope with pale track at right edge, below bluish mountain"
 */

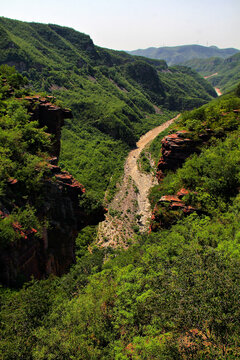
xmin=183 ymin=52 xmax=240 ymax=92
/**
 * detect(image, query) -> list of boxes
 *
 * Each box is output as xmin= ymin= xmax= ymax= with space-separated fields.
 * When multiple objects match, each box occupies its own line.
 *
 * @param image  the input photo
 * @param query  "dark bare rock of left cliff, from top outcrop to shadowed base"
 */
xmin=0 ymin=97 xmax=104 ymax=285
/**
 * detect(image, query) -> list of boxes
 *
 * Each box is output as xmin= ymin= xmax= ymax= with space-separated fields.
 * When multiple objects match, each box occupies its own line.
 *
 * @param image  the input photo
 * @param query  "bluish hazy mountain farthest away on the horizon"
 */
xmin=127 ymin=45 xmax=239 ymax=65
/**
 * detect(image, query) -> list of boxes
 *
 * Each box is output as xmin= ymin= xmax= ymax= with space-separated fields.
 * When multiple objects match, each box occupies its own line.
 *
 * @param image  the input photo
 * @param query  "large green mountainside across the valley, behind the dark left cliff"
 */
xmin=0 ymin=18 xmax=216 ymax=201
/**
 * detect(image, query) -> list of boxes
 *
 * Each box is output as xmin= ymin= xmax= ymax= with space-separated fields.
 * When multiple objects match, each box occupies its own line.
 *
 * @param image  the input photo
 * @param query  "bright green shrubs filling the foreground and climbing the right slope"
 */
xmin=0 ymin=61 xmax=240 ymax=360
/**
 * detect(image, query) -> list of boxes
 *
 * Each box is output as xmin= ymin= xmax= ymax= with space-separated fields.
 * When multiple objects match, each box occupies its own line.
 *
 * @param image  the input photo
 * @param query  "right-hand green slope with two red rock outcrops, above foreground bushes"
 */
xmin=150 ymin=86 xmax=240 ymax=230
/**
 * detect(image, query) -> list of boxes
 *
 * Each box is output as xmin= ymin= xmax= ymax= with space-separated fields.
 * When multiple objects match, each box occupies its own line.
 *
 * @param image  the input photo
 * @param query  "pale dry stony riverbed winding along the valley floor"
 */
xmin=97 ymin=115 xmax=179 ymax=247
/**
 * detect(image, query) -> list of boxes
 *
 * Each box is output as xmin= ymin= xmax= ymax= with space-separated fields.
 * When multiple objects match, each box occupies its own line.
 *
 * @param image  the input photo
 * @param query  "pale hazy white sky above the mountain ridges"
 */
xmin=0 ymin=0 xmax=240 ymax=50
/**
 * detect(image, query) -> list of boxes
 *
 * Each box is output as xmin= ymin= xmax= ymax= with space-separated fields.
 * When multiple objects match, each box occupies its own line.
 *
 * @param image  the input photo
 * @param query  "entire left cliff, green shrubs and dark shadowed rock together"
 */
xmin=0 ymin=65 xmax=104 ymax=285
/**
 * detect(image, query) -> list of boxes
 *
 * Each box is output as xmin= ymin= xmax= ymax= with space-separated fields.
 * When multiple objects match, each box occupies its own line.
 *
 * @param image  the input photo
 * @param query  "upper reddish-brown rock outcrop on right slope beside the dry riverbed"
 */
xmin=157 ymin=130 xmax=212 ymax=181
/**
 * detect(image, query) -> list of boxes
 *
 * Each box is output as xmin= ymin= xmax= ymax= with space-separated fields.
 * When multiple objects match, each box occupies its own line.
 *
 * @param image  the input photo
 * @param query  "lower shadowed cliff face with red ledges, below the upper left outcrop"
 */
xmin=0 ymin=164 xmax=85 ymax=285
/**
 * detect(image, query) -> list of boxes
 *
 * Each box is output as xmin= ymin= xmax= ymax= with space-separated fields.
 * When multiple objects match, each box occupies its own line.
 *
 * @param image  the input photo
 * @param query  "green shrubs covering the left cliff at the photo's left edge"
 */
xmin=0 ymin=65 xmax=50 ymax=245
